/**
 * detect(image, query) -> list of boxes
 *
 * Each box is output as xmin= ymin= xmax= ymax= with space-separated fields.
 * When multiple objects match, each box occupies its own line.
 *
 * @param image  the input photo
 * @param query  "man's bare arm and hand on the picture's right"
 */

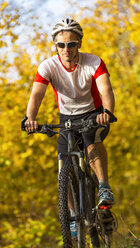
xmin=96 ymin=73 xmax=115 ymax=124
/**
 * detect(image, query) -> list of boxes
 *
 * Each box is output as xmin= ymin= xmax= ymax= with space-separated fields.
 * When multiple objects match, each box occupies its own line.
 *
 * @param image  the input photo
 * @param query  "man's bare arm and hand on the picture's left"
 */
xmin=25 ymin=82 xmax=47 ymax=132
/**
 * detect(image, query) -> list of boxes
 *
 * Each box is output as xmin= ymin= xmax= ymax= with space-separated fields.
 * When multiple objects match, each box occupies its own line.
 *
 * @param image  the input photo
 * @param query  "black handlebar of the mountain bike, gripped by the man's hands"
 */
xmin=21 ymin=109 xmax=117 ymax=137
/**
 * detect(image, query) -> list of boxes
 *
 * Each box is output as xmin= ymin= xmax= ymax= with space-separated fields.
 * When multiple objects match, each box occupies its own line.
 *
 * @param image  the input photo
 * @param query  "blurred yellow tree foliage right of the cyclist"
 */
xmin=81 ymin=0 xmax=140 ymax=236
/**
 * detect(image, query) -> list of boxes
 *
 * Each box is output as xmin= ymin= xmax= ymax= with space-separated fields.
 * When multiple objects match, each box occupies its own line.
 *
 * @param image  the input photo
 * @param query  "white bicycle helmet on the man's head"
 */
xmin=52 ymin=18 xmax=83 ymax=40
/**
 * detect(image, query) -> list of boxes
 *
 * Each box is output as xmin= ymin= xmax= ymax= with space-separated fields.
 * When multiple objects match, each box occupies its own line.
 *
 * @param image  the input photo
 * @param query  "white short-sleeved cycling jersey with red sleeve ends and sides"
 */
xmin=34 ymin=53 xmax=108 ymax=115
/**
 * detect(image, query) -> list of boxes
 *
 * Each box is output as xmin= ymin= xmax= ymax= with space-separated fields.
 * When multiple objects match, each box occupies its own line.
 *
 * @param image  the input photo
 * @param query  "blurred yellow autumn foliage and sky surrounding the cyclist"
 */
xmin=0 ymin=0 xmax=140 ymax=248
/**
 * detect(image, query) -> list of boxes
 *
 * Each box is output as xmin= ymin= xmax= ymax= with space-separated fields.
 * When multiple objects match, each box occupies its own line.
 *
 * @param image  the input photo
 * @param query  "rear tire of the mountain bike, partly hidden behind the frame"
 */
xmin=86 ymin=177 xmax=100 ymax=248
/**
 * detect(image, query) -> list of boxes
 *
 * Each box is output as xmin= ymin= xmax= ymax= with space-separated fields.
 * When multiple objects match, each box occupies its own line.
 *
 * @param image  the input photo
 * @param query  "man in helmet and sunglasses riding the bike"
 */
xmin=25 ymin=18 xmax=114 ymax=236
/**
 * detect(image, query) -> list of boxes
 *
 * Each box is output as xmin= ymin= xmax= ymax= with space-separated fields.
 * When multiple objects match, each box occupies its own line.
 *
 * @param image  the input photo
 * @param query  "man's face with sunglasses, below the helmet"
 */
xmin=56 ymin=31 xmax=81 ymax=62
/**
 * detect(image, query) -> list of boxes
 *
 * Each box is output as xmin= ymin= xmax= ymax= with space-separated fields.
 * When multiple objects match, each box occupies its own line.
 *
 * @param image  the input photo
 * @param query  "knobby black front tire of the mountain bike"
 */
xmin=59 ymin=164 xmax=85 ymax=248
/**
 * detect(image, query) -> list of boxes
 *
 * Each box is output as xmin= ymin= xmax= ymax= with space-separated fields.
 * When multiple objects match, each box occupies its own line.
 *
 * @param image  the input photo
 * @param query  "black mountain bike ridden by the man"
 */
xmin=21 ymin=109 xmax=117 ymax=248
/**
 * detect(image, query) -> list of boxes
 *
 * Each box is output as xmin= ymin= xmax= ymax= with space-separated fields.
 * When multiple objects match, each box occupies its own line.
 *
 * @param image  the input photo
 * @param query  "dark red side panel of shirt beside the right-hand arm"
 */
xmin=91 ymin=76 xmax=102 ymax=109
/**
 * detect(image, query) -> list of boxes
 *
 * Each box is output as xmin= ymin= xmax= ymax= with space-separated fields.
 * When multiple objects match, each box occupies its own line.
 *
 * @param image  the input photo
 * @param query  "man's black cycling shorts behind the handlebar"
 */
xmin=58 ymin=106 xmax=109 ymax=153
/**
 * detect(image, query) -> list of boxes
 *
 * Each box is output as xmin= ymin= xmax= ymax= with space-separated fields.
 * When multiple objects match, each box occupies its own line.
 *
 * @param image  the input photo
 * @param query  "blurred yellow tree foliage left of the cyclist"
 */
xmin=0 ymin=2 xmax=61 ymax=248
